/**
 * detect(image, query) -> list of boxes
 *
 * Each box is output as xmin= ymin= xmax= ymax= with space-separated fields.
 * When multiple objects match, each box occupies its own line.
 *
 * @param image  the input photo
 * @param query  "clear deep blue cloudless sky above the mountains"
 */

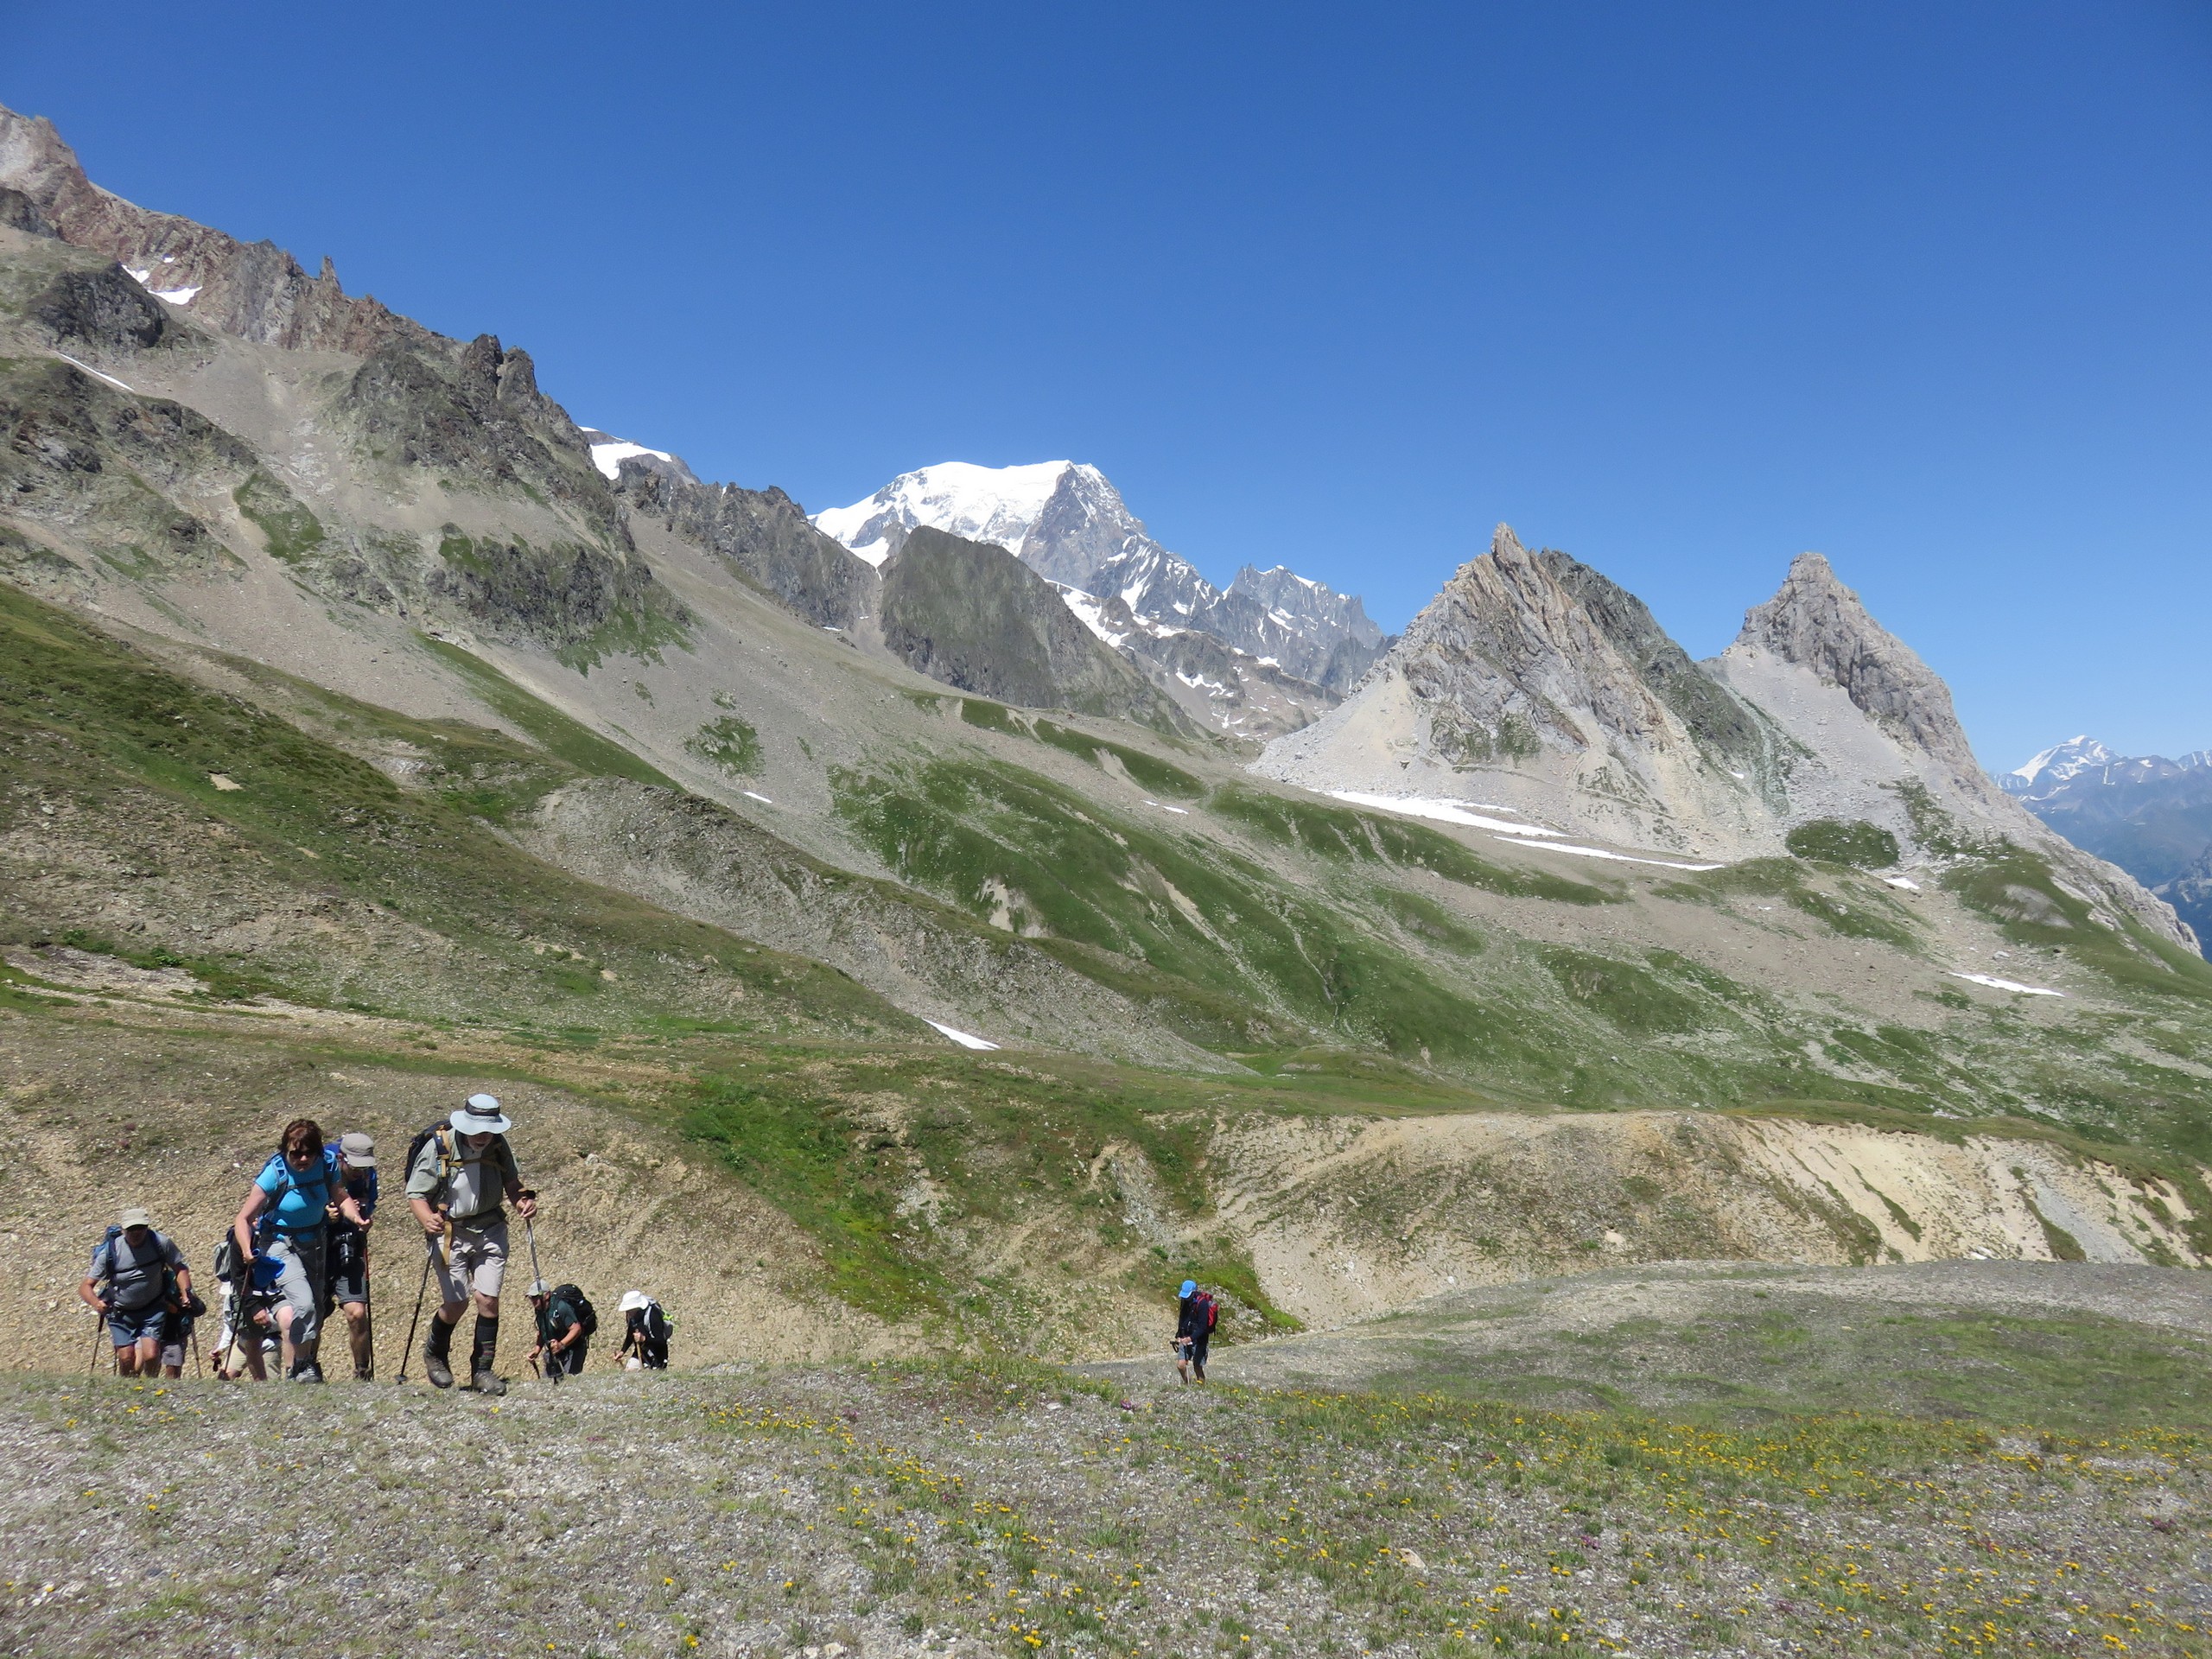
xmin=0 ymin=0 xmax=2212 ymax=766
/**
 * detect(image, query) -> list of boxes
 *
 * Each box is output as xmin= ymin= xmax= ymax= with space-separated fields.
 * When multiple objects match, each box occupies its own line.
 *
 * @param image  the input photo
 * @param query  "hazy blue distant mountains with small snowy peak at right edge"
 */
xmin=1998 ymin=736 xmax=2212 ymax=955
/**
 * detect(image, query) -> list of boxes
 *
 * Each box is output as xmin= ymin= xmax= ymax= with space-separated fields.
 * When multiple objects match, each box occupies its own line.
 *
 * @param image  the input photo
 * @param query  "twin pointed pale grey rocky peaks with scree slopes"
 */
xmin=1256 ymin=526 xmax=2195 ymax=943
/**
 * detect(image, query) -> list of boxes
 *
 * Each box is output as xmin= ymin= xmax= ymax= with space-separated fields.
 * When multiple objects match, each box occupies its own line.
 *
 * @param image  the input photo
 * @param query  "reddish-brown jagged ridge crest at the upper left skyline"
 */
xmin=0 ymin=108 xmax=422 ymax=356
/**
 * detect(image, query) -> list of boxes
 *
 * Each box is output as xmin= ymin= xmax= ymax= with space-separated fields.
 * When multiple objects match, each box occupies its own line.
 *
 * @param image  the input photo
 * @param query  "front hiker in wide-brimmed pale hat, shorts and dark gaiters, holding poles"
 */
xmin=407 ymin=1095 xmax=537 ymax=1394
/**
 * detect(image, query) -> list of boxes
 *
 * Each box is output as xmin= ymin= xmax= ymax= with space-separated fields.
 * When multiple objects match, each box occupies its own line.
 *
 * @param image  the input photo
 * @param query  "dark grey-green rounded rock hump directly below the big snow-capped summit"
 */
xmin=880 ymin=526 xmax=1188 ymax=730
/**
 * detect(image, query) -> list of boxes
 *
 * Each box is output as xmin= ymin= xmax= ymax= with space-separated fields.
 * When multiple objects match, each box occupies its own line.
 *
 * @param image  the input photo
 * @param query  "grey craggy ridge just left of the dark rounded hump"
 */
xmin=615 ymin=468 xmax=878 ymax=628
